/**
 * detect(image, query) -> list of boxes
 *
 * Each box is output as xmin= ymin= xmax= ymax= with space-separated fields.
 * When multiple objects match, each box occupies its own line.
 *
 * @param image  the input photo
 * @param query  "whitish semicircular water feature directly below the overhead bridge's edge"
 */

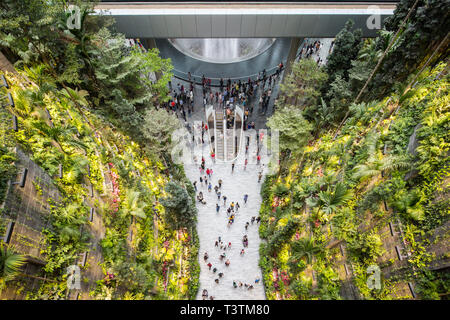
xmin=169 ymin=38 xmax=276 ymax=63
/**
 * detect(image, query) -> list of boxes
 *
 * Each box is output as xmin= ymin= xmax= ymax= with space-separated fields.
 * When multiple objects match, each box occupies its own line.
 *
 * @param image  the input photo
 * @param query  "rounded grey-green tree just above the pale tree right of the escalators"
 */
xmin=280 ymin=58 xmax=327 ymax=108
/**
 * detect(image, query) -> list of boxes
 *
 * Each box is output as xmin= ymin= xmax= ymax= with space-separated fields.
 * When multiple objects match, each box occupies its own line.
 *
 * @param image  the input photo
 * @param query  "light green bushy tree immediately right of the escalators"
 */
xmin=267 ymin=106 xmax=313 ymax=154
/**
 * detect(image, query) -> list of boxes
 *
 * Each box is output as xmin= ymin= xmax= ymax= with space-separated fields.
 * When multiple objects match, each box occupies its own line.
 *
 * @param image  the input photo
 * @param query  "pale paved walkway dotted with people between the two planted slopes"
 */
xmin=185 ymin=130 xmax=267 ymax=300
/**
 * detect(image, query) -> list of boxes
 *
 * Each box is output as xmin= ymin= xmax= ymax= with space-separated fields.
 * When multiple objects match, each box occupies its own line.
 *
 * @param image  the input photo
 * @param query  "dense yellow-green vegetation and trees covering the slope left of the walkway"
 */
xmin=0 ymin=0 xmax=199 ymax=299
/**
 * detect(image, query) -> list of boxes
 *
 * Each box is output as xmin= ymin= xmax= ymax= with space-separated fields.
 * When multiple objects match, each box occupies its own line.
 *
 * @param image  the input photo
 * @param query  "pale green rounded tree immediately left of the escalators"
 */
xmin=142 ymin=108 xmax=180 ymax=152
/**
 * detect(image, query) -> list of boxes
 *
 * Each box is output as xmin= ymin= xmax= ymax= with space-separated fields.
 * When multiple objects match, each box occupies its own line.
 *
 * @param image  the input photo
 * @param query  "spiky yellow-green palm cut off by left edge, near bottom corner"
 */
xmin=0 ymin=242 xmax=26 ymax=291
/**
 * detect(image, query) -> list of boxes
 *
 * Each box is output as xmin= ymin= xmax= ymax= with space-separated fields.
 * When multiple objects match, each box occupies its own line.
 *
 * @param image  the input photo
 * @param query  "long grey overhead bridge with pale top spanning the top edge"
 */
xmin=95 ymin=1 xmax=398 ymax=38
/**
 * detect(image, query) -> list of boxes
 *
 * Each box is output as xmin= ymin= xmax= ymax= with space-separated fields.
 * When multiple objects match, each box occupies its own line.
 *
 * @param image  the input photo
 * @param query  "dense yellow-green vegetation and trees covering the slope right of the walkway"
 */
xmin=260 ymin=1 xmax=450 ymax=299
